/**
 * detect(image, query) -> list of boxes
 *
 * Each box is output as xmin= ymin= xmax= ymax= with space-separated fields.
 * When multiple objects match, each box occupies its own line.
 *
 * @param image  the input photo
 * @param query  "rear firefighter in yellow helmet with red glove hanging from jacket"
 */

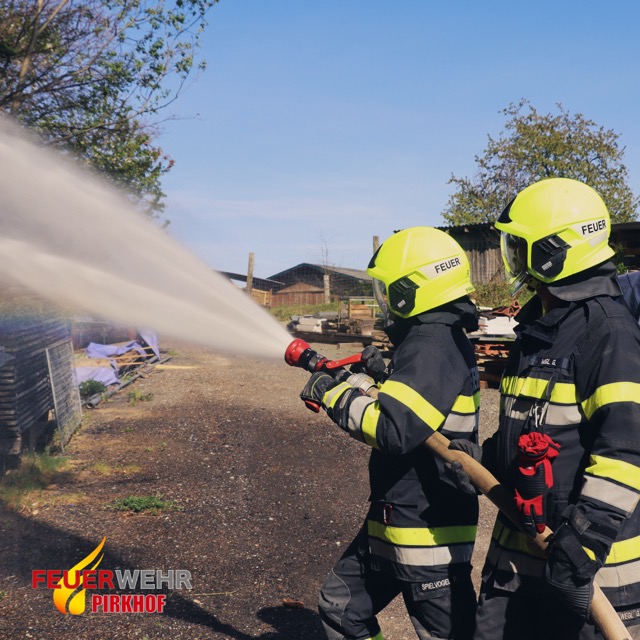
xmin=452 ymin=178 xmax=640 ymax=640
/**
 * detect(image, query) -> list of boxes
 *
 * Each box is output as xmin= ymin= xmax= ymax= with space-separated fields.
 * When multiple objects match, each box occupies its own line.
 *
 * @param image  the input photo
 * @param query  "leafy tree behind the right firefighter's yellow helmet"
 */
xmin=442 ymin=100 xmax=638 ymax=225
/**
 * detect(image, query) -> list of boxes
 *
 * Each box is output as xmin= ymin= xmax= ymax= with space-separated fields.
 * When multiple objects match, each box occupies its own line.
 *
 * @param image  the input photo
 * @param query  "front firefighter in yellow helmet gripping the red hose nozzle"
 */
xmin=301 ymin=227 xmax=480 ymax=640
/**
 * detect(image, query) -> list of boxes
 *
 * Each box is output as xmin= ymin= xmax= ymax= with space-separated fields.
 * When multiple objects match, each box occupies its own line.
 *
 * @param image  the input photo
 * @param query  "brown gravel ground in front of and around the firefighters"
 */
xmin=0 ymin=345 xmax=498 ymax=640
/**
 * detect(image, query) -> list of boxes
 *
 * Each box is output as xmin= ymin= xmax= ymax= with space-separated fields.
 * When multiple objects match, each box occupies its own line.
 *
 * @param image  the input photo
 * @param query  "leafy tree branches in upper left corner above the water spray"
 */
xmin=0 ymin=0 xmax=217 ymax=213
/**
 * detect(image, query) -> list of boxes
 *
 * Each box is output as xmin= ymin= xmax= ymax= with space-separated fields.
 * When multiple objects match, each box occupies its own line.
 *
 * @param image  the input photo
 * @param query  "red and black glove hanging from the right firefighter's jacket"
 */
xmin=514 ymin=431 xmax=560 ymax=538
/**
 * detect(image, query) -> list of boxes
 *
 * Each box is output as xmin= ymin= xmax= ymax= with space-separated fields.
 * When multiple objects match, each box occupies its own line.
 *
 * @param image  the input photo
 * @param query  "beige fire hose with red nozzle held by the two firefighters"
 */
xmin=284 ymin=339 xmax=631 ymax=640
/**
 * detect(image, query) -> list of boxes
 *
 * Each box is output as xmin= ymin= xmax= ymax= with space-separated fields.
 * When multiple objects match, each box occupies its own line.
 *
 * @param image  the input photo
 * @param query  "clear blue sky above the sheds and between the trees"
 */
xmin=159 ymin=0 xmax=640 ymax=277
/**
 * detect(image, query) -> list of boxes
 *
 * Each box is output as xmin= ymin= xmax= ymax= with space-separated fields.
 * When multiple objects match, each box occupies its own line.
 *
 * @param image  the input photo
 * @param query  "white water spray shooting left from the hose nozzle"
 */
xmin=0 ymin=118 xmax=291 ymax=358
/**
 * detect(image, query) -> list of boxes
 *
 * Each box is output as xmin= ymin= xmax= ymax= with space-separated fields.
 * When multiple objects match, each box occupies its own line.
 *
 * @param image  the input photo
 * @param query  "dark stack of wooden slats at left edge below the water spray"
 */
xmin=0 ymin=290 xmax=82 ymax=472
